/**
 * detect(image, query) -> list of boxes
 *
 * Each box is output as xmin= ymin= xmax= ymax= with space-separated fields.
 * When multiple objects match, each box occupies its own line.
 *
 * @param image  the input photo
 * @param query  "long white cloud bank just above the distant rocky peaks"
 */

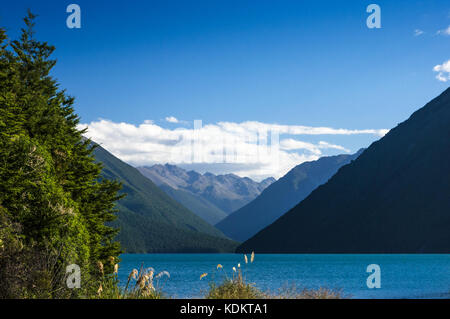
xmin=79 ymin=120 xmax=388 ymax=180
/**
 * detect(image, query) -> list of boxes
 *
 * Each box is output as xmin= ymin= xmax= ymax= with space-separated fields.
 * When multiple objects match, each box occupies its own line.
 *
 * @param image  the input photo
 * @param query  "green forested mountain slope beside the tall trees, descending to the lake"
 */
xmin=94 ymin=146 xmax=237 ymax=253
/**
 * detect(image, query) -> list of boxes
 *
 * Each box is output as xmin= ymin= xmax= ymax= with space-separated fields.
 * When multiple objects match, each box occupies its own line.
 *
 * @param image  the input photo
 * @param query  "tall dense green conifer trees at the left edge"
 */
xmin=0 ymin=13 xmax=120 ymax=297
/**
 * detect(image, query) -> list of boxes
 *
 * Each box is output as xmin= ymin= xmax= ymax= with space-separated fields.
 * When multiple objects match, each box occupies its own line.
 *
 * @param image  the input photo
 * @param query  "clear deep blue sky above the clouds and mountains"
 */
xmin=0 ymin=0 xmax=450 ymax=179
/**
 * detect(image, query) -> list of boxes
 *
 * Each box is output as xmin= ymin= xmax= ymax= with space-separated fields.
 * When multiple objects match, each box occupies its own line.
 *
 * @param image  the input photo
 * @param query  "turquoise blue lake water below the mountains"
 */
xmin=119 ymin=254 xmax=450 ymax=298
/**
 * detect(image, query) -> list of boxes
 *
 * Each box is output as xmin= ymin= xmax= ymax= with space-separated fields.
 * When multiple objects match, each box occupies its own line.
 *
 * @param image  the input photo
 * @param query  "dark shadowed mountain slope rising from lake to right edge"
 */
xmin=238 ymin=88 xmax=450 ymax=253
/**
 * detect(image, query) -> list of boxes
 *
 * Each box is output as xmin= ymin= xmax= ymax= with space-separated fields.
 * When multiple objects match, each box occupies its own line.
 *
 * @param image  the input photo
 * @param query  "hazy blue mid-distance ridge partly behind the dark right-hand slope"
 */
xmin=216 ymin=149 xmax=363 ymax=241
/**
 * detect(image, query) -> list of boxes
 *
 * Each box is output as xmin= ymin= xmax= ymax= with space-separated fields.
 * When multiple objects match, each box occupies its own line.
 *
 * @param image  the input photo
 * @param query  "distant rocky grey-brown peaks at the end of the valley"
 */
xmin=137 ymin=164 xmax=275 ymax=225
